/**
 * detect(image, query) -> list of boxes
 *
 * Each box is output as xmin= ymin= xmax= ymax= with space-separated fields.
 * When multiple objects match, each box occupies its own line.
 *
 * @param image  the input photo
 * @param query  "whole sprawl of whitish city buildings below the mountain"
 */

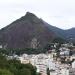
xmin=8 ymin=44 xmax=75 ymax=75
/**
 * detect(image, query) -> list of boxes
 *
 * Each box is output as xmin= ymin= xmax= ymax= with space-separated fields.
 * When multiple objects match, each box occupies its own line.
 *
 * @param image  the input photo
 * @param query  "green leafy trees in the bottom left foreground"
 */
xmin=0 ymin=54 xmax=37 ymax=75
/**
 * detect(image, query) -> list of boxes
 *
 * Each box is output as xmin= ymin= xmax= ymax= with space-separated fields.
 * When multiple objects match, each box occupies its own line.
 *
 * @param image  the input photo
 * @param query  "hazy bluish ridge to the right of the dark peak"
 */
xmin=43 ymin=21 xmax=75 ymax=43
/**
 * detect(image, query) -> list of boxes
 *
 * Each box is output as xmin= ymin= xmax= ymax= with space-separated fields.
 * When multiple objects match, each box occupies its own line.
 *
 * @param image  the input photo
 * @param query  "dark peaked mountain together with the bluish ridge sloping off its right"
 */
xmin=0 ymin=12 xmax=75 ymax=48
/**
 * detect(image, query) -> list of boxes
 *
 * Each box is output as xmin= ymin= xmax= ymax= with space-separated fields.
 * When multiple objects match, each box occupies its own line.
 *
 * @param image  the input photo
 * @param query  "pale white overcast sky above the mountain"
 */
xmin=0 ymin=0 xmax=75 ymax=29
